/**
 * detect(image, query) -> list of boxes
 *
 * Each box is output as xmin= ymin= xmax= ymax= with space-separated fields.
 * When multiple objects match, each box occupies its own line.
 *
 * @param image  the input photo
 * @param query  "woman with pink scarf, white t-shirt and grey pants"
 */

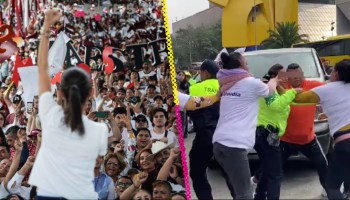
xmin=213 ymin=52 xmax=277 ymax=199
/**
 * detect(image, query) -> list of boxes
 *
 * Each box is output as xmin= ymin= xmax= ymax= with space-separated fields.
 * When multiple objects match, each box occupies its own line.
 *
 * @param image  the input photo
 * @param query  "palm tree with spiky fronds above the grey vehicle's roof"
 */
xmin=261 ymin=22 xmax=308 ymax=49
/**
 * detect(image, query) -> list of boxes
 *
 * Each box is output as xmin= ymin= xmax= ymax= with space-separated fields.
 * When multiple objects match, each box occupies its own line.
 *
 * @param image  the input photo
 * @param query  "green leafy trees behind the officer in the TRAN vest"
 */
xmin=172 ymin=23 xmax=222 ymax=69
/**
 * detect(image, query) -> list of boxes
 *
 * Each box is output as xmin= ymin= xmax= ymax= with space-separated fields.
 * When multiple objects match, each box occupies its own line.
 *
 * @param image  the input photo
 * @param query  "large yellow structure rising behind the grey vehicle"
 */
xmin=209 ymin=0 xmax=298 ymax=47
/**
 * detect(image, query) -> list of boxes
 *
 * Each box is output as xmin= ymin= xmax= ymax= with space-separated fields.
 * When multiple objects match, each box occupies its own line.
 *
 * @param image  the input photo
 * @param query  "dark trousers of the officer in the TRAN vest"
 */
xmin=189 ymin=128 xmax=215 ymax=199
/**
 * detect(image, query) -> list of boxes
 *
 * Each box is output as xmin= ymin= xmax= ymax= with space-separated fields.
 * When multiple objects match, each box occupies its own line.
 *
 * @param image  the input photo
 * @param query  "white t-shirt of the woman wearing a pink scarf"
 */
xmin=213 ymin=77 xmax=269 ymax=149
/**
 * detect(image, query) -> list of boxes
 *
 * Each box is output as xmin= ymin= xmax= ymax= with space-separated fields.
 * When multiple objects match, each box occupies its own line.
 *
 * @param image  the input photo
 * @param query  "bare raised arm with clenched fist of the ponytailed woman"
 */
xmin=38 ymin=9 xmax=61 ymax=95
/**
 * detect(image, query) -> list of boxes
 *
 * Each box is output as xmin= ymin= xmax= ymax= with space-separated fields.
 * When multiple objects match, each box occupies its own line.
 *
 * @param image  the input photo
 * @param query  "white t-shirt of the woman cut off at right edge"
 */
xmin=312 ymin=81 xmax=350 ymax=136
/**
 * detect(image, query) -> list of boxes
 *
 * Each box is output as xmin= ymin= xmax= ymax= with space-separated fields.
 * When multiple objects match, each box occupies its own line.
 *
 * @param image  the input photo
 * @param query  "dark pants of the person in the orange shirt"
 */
xmin=280 ymin=138 xmax=328 ymax=189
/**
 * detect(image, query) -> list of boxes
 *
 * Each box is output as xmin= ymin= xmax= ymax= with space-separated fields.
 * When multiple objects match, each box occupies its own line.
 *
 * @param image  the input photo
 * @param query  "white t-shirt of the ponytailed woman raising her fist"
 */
xmin=29 ymin=92 xmax=108 ymax=199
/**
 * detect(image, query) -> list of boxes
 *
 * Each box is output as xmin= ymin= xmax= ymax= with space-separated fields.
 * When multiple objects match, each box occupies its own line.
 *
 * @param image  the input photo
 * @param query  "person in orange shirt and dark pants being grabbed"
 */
xmin=280 ymin=63 xmax=328 ymax=194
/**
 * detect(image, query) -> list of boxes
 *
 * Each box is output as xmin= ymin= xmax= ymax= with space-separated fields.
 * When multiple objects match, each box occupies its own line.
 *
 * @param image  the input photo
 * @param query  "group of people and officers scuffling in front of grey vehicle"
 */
xmin=177 ymin=52 xmax=350 ymax=200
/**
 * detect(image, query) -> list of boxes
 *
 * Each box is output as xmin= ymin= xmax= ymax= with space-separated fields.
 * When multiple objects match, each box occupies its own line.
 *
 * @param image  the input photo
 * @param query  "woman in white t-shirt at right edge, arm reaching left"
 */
xmin=295 ymin=59 xmax=350 ymax=199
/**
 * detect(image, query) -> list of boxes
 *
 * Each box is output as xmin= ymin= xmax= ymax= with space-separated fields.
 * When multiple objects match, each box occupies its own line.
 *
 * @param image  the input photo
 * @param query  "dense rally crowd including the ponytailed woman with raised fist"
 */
xmin=0 ymin=0 xmax=186 ymax=199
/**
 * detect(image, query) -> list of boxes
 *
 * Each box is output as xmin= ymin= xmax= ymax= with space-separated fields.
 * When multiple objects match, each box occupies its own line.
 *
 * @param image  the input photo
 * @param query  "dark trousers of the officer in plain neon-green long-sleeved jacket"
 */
xmin=254 ymin=127 xmax=283 ymax=200
